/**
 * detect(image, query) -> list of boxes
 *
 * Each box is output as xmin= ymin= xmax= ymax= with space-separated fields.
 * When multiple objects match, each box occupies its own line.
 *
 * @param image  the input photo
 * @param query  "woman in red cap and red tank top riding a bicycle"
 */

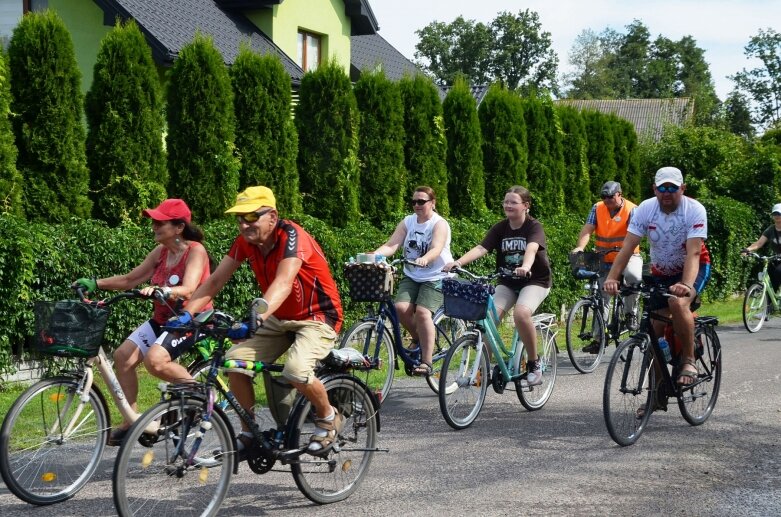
xmin=74 ymin=199 xmax=210 ymax=445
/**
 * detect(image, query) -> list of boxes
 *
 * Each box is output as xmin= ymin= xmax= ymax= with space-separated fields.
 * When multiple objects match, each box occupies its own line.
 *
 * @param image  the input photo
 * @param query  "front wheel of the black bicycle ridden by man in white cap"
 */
xmin=602 ymin=337 xmax=656 ymax=446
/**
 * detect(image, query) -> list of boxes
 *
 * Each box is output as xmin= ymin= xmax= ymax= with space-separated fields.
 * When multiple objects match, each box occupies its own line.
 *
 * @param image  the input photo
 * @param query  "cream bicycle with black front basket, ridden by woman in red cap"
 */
xmin=0 ymin=289 xmax=174 ymax=505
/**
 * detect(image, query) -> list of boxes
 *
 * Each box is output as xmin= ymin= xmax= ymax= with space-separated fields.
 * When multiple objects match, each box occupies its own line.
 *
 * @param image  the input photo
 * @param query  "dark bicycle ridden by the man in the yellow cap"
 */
xmin=113 ymin=302 xmax=383 ymax=516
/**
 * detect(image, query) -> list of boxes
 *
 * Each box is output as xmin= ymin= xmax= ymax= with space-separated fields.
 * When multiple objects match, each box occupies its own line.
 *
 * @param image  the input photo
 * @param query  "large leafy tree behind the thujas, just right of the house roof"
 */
xmin=415 ymin=9 xmax=558 ymax=92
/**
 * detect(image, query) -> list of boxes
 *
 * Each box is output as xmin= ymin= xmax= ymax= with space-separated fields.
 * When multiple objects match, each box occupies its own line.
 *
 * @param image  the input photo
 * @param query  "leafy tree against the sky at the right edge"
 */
xmin=732 ymin=29 xmax=781 ymax=128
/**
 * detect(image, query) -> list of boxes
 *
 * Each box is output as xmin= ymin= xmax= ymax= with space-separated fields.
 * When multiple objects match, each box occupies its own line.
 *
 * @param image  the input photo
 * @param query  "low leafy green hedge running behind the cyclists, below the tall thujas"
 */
xmin=0 ymin=202 xmax=761 ymax=376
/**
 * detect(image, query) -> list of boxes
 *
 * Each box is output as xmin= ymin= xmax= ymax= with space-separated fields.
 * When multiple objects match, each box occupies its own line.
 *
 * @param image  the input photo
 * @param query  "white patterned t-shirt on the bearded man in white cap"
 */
xmin=629 ymin=196 xmax=708 ymax=276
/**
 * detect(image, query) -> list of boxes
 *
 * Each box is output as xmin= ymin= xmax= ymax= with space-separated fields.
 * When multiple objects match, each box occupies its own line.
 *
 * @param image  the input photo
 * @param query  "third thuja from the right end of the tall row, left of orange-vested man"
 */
xmin=556 ymin=105 xmax=599 ymax=218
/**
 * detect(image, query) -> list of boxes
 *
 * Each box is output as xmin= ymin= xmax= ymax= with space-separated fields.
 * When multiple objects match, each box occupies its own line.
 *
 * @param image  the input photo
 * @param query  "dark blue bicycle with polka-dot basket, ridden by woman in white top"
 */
xmin=339 ymin=259 xmax=466 ymax=403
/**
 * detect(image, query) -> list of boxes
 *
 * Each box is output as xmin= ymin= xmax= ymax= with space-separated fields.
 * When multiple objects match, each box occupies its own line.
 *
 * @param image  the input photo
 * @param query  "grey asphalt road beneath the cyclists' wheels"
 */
xmin=0 ymin=319 xmax=781 ymax=517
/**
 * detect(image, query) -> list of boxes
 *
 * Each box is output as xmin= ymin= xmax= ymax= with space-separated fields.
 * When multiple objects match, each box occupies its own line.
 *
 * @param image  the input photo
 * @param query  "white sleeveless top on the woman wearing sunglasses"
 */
xmin=402 ymin=213 xmax=453 ymax=282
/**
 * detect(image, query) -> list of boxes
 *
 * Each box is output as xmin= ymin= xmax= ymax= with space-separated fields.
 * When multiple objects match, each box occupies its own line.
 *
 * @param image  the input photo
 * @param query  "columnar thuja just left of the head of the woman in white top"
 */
xmin=355 ymin=72 xmax=412 ymax=226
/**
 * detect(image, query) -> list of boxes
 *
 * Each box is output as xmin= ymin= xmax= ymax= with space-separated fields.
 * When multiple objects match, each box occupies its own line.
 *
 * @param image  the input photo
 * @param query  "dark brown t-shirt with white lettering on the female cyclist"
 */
xmin=480 ymin=216 xmax=552 ymax=290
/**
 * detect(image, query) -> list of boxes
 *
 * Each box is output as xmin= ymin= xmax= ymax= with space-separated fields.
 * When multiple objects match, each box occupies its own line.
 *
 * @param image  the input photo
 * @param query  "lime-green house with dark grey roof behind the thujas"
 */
xmin=0 ymin=0 xmax=419 ymax=92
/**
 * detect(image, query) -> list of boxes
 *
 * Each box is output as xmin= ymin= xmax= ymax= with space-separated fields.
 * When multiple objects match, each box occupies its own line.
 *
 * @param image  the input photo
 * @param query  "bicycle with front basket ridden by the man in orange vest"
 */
xmin=565 ymin=250 xmax=636 ymax=373
